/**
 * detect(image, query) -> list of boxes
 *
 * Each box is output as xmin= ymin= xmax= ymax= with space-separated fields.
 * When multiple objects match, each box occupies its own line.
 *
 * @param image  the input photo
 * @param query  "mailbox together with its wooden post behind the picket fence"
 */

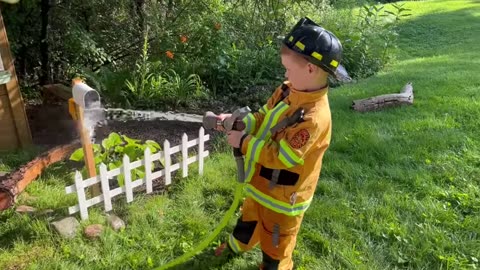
xmin=68 ymin=79 xmax=101 ymax=197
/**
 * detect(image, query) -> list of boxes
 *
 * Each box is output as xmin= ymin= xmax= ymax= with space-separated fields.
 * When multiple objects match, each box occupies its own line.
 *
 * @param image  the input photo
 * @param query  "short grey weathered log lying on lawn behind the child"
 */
xmin=350 ymin=82 xmax=413 ymax=112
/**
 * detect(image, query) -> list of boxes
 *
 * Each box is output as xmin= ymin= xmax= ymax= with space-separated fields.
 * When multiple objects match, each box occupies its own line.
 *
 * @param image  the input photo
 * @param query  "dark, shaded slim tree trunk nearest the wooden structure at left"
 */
xmin=39 ymin=0 xmax=50 ymax=85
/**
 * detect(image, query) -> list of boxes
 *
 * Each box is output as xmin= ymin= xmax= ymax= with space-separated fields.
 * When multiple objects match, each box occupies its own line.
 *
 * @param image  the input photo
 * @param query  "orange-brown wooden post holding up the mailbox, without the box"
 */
xmin=75 ymin=104 xmax=101 ymax=197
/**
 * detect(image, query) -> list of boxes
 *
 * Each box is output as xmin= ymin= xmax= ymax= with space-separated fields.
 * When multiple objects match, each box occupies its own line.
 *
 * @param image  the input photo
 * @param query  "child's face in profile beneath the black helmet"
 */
xmin=281 ymin=54 xmax=312 ymax=91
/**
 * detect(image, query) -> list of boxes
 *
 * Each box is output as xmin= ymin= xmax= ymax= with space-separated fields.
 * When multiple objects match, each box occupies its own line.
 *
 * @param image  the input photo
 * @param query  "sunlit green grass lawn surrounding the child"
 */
xmin=0 ymin=0 xmax=480 ymax=270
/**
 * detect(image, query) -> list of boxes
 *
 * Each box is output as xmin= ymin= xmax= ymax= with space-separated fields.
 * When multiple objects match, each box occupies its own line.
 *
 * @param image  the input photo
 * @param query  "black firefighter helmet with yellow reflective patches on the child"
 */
xmin=283 ymin=17 xmax=351 ymax=81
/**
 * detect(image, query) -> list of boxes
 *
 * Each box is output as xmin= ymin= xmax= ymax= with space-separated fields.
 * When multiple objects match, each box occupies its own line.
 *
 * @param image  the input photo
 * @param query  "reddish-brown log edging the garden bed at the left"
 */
xmin=0 ymin=141 xmax=81 ymax=211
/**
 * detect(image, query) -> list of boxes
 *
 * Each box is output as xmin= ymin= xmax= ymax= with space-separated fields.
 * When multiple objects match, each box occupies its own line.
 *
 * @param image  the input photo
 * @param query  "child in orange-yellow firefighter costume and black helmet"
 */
xmin=216 ymin=18 xmax=348 ymax=270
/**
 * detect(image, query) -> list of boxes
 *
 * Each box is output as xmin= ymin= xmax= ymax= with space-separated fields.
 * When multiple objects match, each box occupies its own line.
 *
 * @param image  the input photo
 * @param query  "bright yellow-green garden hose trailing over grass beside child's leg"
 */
xmin=156 ymin=183 xmax=245 ymax=270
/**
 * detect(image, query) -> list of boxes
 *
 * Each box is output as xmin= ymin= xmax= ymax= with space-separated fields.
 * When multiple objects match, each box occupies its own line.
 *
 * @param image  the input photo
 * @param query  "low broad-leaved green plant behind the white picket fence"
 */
xmin=70 ymin=132 xmax=161 ymax=186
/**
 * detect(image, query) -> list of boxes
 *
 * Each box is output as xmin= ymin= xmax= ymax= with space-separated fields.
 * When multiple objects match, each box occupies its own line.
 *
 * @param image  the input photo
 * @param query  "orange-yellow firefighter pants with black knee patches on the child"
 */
xmin=228 ymin=197 xmax=303 ymax=270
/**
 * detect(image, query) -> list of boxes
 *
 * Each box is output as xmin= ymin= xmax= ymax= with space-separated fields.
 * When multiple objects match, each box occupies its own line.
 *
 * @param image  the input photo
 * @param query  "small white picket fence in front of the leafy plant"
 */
xmin=65 ymin=127 xmax=210 ymax=220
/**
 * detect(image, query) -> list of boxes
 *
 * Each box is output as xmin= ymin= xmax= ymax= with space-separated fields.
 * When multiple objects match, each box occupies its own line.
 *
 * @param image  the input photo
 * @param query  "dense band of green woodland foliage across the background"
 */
xmin=4 ymin=0 xmax=406 ymax=110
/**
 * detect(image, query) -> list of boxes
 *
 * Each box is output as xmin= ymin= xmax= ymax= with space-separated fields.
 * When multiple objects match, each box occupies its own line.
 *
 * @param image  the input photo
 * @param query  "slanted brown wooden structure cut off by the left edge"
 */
xmin=0 ymin=10 xmax=32 ymax=149
